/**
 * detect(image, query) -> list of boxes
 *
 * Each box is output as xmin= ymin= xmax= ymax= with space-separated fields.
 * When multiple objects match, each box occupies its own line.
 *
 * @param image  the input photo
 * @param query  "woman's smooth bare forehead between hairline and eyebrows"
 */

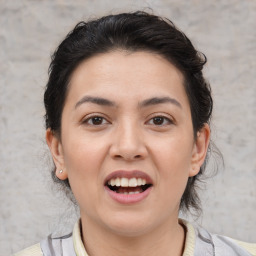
xmin=66 ymin=51 xmax=188 ymax=109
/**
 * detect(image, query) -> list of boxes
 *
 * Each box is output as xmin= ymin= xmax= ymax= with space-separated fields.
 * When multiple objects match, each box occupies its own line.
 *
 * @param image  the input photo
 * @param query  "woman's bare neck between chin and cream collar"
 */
xmin=81 ymin=216 xmax=185 ymax=256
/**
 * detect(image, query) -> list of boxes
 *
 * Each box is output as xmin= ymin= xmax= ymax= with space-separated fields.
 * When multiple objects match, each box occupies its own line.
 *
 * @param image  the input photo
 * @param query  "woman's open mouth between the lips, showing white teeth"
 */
xmin=105 ymin=177 xmax=152 ymax=195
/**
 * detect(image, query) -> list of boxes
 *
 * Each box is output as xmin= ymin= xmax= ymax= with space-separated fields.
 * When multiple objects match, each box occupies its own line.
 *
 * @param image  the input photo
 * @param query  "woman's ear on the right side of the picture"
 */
xmin=189 ymin=124 xmax=211 ymax=177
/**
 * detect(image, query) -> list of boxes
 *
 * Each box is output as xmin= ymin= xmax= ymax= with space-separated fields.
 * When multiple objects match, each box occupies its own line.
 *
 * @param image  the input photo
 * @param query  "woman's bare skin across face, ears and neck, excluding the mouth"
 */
xmin=46 ymin=51 xmax=210 ymax=256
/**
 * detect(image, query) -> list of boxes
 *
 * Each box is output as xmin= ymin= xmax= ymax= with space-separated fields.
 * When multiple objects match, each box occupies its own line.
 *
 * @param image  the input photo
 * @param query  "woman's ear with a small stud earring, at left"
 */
xmin=45 ymin=129 xmax=68 ymax=180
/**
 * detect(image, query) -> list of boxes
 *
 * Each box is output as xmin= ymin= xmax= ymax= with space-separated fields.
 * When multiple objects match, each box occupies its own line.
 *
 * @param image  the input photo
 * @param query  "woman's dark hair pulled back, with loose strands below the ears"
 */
xmin=44 ymin=11 xmax=213 ymax=214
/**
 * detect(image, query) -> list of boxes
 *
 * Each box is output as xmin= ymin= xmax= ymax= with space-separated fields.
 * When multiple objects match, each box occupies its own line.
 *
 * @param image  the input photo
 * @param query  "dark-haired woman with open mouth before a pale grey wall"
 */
xmin=14 ymin=12 xmax=256 ymax=256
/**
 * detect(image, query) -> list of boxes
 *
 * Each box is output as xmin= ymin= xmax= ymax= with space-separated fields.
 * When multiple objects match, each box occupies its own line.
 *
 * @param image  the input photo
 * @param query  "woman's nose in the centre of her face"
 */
xmin=110 ymin=122 xmax=148 ymax=161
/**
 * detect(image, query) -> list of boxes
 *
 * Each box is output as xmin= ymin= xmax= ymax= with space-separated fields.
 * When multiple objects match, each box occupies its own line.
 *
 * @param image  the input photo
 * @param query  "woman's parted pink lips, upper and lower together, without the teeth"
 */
xmin=104 ymin=170 xmax=153 ymax=204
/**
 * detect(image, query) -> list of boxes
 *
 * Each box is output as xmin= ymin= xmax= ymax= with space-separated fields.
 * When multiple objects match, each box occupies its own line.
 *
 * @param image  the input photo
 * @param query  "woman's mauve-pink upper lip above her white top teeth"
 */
xmin=104 ymin=170 xmax=153 ymax=185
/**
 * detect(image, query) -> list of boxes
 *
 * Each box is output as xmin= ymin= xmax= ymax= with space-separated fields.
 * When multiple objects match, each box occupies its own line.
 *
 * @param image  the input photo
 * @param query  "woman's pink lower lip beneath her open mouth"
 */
xmin=105 ymin=186 xmax=152 ymax=204
